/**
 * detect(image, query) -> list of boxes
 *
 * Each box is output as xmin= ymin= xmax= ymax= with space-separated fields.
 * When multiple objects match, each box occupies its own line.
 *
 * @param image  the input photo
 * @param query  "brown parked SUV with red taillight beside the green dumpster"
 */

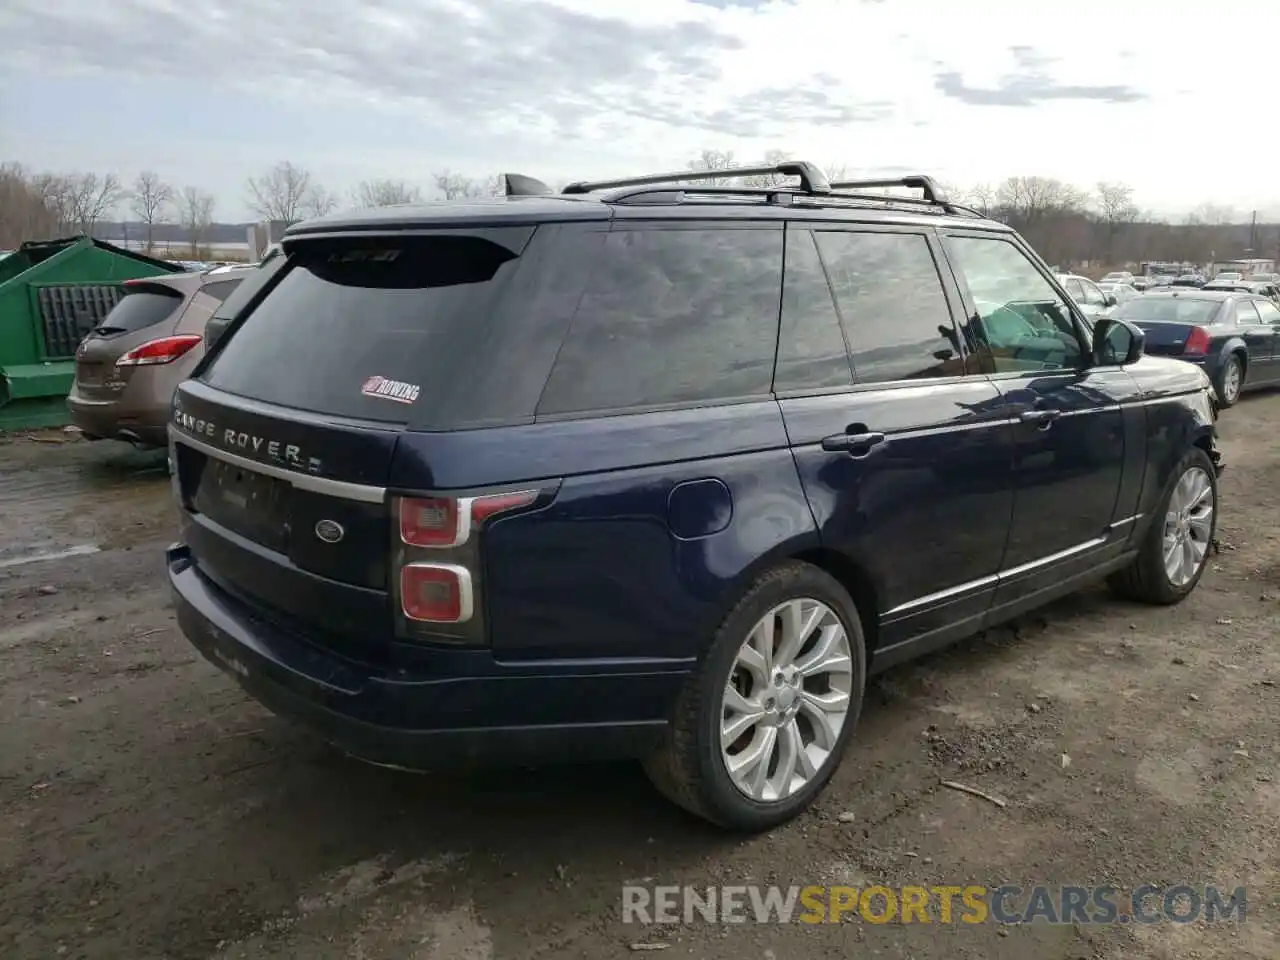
xmin=67 ymin=266 xmax=248 ymax=448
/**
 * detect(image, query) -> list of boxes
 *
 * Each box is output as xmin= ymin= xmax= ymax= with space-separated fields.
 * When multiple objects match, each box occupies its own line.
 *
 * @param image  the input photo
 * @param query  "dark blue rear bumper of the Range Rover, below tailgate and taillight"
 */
xmin=168 ymin=545 xmax=689 ymax=769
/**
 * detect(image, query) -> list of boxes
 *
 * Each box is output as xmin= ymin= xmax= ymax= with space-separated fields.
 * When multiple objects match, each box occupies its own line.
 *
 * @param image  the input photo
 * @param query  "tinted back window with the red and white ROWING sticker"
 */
xmin=202 ymin=228 xmax=527 ymax=424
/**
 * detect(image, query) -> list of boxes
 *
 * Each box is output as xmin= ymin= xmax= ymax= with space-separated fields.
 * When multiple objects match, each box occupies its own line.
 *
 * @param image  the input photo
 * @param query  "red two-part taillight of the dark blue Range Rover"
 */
xmin=393 ymin=490 xmax=540 ymax=644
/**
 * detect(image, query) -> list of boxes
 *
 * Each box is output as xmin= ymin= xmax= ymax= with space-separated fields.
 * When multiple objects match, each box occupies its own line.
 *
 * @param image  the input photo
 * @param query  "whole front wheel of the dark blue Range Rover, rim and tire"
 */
xmin=1107 ymin=447 xmax=1217 ymax=604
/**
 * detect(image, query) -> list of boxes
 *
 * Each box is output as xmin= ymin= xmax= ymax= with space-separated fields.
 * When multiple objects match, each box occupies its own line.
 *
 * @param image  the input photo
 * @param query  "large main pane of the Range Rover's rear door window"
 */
xmin=814 ymin=230 xmax=965 ymax=383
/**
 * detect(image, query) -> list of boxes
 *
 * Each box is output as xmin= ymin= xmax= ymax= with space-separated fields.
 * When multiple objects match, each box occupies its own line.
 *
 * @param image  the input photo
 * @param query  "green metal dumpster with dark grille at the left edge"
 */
xmin=0 ymin=237 xmax=182 ymax=431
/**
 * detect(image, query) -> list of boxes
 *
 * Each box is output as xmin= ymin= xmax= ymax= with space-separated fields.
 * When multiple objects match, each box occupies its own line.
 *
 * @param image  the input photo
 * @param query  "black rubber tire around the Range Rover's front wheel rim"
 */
xmin=1107 ymin=447 xmax=1217 ymax=604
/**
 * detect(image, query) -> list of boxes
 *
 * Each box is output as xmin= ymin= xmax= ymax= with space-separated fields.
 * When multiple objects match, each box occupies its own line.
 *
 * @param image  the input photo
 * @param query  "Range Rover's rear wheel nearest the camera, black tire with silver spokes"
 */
xmin=644 ymin=561 xmax=867 ymax=832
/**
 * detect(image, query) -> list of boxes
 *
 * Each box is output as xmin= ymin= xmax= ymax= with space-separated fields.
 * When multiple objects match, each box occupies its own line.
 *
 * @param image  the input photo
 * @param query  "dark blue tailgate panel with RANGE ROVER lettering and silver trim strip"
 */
xmin=170 ymin=380 xmax=398 ymax=658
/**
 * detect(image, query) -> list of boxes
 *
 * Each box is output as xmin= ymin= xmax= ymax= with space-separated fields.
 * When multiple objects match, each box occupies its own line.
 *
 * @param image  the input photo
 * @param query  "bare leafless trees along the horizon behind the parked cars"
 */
xmin=0 ymin=150 xmax=1280 ymax=269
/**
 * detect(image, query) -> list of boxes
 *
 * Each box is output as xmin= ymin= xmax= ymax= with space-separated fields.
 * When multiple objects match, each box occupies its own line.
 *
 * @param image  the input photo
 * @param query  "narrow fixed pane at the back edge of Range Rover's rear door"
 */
xmin=773 ymin=227 xmax=854 ymax=392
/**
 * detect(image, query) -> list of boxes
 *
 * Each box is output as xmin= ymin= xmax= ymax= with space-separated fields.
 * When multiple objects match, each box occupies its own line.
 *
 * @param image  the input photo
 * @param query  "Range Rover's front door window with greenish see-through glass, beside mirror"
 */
xmin=946 ymin=237 xmax=1084 ymax=372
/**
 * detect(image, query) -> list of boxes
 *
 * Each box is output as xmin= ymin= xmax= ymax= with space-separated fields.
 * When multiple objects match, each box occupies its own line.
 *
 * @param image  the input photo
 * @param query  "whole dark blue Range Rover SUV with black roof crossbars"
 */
xmin=168 ymin=163 xmax=1221 ymax=829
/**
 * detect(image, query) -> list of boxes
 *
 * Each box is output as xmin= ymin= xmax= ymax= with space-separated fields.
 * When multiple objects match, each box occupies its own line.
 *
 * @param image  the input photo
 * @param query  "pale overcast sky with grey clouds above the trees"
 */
xmin=0 ymin=0 xmax=1280 ymax=220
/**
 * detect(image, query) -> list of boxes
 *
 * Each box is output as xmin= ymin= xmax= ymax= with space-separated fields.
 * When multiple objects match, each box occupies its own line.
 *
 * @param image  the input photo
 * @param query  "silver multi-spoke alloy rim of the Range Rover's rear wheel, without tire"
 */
xmin=721 ymin=598 xmax=854 ymax=803
